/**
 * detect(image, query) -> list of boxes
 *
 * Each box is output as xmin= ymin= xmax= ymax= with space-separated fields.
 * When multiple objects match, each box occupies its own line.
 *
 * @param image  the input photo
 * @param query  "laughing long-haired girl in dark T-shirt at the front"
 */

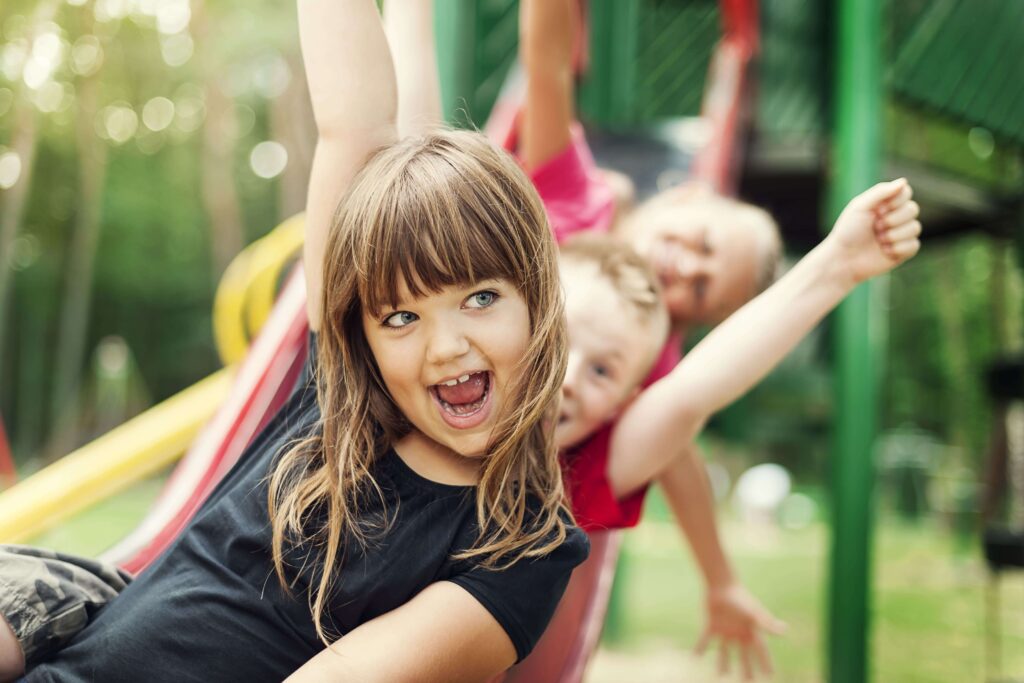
xmin=0 ymin=0 xmax=587 ymax=681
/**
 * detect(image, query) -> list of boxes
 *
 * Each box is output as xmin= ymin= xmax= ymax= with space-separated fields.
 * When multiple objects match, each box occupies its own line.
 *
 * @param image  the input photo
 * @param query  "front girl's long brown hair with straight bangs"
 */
xmin=268 ymin=130 xmax=570 ymax=643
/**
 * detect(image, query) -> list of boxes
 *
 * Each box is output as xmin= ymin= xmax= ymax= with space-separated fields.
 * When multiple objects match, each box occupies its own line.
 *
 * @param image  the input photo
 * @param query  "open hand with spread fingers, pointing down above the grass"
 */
xmin=694 ymin=584 xmax=786 ymax=681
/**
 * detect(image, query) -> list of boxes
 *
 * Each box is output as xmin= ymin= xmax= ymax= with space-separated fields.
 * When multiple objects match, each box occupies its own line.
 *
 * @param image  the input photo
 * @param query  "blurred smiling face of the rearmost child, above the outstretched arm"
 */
xmin=630 ymin=205 xmax=761 ymax=327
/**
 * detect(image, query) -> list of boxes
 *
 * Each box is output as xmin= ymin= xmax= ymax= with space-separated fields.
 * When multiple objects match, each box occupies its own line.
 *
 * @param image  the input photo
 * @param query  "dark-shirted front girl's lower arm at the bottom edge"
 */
xmin=288 ymin=581 xmax=516 ymax=683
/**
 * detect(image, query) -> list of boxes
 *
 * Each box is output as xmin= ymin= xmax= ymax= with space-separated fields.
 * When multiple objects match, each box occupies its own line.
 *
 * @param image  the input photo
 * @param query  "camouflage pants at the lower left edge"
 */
xmin=0 ymin=545 xmax=131 ymax=667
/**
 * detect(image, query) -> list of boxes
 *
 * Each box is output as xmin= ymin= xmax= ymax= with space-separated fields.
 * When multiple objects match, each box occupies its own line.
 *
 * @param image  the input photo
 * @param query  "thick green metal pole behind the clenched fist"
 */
xmin=826 ymin=0 xmax=885 ymax=683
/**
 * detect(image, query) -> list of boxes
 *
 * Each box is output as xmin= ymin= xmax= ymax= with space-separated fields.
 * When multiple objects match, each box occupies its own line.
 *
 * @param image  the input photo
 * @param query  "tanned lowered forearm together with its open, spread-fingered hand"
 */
xmin=657 ymin=442 xmax=785 ymax=680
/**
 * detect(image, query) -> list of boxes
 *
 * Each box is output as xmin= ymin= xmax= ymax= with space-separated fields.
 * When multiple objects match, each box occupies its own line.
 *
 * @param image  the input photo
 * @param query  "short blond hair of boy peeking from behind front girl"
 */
xmin=559 ymin=234 xmax=669 ymax=375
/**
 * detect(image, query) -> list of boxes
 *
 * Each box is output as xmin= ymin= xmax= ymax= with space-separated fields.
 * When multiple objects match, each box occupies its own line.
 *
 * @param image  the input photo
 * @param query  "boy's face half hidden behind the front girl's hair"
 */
xmin=555 ymin=259 xmax=665 ymax=449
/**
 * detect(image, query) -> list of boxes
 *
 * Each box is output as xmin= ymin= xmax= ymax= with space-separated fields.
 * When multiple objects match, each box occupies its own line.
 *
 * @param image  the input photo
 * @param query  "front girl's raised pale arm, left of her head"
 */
xmin=298 ymin=0 xmax=397 ymax=330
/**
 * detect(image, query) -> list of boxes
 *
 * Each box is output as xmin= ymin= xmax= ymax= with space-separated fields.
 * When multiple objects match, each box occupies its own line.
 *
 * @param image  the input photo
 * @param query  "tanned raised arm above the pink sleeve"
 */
xmin=519 ymin=0 xmax=573 ymax=171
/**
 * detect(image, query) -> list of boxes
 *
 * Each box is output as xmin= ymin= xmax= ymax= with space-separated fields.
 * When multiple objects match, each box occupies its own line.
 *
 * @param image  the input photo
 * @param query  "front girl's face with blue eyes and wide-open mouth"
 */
xmin=362 ymin=280 xmax=530 ymax=457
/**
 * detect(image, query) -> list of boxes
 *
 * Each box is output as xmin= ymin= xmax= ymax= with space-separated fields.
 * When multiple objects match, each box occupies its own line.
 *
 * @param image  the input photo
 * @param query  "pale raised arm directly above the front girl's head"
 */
xmin=384 ymin=0 xmax=444 ymax=137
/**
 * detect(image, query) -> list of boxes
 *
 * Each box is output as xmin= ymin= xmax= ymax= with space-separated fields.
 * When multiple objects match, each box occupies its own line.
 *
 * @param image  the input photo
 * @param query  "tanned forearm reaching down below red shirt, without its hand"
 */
xmin=657 ymin=444 xmax=735 ymax=590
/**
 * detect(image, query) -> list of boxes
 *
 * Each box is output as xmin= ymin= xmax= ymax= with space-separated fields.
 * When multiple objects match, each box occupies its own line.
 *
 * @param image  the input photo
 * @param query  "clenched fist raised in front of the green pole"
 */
xmin=826 ymin=178 xmax=921 ymax=285
